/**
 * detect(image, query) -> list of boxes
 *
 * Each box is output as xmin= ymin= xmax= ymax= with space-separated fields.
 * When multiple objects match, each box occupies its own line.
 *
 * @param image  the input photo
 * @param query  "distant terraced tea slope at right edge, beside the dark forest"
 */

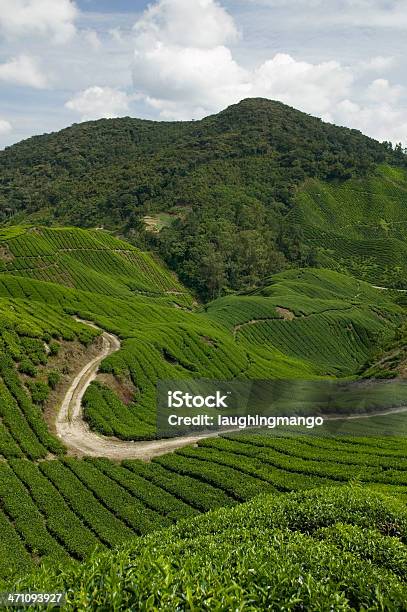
xmin=289 ymin=166 xmax=407 ymax=289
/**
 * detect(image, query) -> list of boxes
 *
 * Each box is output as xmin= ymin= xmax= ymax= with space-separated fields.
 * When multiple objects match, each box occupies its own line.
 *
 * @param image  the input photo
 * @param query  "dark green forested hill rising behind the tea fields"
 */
xmin=0 ymin=99 xmax=404 ymax=298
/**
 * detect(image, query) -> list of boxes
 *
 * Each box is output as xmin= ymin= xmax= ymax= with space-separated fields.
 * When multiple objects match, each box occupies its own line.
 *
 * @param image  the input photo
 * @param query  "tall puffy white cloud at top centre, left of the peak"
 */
xmin=133 ymin=0 xmax=250 ymax=119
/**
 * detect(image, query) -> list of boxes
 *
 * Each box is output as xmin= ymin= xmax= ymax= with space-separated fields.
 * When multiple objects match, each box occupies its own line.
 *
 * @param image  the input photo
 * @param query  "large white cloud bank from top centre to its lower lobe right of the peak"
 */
xmin=133 ymin=0 xmax=353 ymax=119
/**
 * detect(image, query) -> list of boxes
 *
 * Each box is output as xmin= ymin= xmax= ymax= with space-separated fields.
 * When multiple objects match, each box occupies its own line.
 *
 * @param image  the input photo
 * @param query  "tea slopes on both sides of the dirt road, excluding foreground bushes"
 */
xmin=0 ymin=227 xmax=407 ymax=580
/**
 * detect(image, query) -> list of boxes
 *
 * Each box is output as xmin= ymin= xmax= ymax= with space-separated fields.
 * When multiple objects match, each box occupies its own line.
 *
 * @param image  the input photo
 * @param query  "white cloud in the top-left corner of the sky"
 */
xmin=0 ymin=0 xmax=79 ymax=43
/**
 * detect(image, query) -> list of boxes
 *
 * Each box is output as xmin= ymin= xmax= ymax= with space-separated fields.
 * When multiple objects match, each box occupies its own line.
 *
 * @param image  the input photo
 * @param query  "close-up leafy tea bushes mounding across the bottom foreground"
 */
xmin=7 ymin=487 xmax=407 ymax=611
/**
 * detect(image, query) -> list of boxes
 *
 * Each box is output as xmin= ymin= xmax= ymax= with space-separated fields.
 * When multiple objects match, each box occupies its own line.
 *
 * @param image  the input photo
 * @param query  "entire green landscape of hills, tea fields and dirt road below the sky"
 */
xmin=0 ymin=100 xmax=407 ymax=610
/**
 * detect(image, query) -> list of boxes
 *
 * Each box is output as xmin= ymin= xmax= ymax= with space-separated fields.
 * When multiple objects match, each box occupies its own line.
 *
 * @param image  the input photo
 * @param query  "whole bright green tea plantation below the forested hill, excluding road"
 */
xmin=0 ymin=226 xmax=407 ymax=610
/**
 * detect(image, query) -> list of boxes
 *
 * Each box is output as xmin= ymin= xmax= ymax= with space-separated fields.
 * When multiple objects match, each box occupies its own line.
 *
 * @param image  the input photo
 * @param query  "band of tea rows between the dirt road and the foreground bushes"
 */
xmin=0 ymin=428 xmax=407 ymax=580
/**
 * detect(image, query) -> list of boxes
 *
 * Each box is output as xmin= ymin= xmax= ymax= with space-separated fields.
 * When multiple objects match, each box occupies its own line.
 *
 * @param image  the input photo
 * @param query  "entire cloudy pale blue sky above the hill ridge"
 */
xmin=0 ymin=0 xmax=407 ymax=149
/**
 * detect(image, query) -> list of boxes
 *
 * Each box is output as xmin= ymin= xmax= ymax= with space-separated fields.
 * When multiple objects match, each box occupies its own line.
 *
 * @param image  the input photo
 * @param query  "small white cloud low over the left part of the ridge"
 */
xmin=65 ymin=86 xmax=130 ymax=121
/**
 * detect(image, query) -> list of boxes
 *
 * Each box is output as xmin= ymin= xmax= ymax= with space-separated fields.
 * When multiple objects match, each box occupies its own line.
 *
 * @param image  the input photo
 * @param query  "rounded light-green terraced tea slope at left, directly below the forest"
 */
xmin=0 ymin=227 xmax=188 ymax=301
